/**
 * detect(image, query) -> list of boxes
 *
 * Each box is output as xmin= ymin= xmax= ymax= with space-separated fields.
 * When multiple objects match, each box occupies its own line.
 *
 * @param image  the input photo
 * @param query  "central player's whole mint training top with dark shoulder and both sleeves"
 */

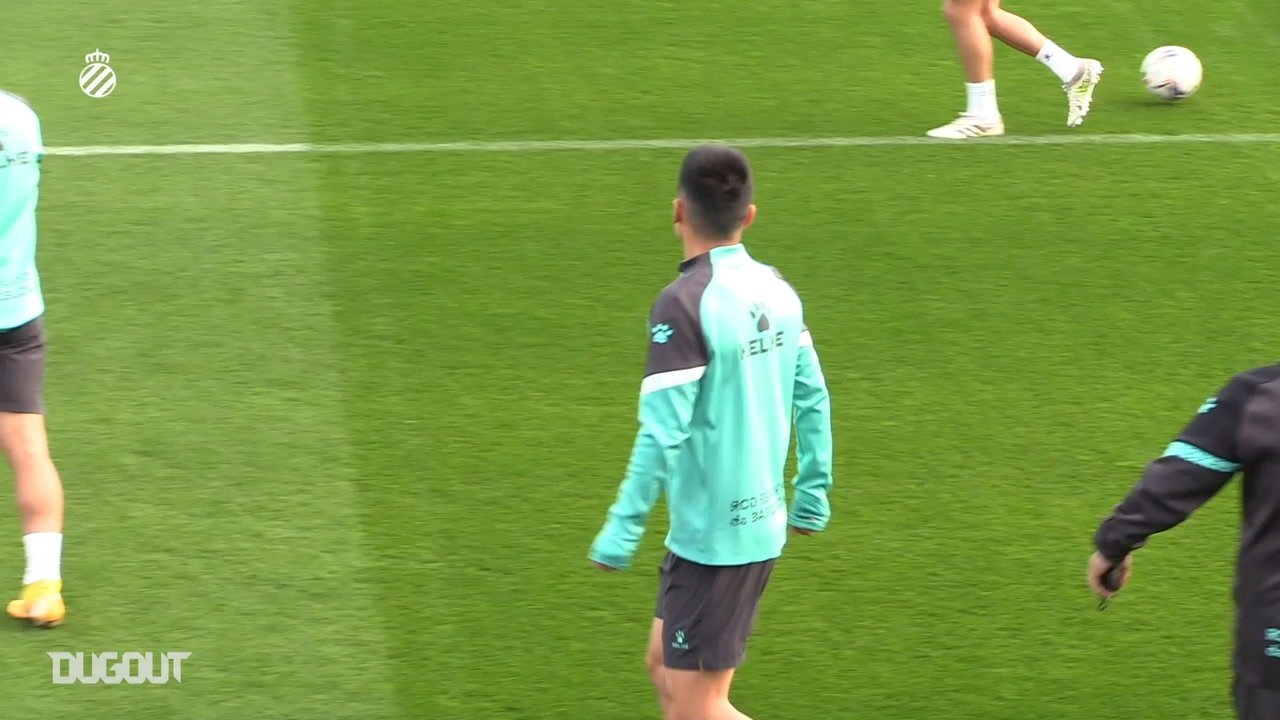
xmin=589 ymin=245 xmax=832 ymax=569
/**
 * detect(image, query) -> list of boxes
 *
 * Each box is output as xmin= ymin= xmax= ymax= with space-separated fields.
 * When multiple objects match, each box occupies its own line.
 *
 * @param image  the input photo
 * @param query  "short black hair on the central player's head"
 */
xmin=680 ymin=145 xmax=753 ymax=238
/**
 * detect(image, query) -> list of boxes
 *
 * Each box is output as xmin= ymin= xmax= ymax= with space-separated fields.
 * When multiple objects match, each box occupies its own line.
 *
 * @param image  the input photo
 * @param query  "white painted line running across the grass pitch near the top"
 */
xmin=46 ymin=133 xmax=1280 ymax=158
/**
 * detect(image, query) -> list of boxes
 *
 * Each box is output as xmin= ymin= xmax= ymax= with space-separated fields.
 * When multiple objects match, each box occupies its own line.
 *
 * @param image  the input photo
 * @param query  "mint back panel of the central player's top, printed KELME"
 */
xmin=667 ymin=245 xmax=804 ymax=565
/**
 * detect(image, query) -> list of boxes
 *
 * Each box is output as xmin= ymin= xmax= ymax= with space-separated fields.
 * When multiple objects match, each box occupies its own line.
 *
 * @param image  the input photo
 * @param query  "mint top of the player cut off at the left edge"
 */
xmin=0 ymin=91 xmax=45 ymax=329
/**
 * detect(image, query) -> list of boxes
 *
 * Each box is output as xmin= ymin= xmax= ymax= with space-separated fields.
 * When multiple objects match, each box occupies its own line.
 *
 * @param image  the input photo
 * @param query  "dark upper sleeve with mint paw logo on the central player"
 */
xmin=644 ymin=281 xmax=708 ymax=382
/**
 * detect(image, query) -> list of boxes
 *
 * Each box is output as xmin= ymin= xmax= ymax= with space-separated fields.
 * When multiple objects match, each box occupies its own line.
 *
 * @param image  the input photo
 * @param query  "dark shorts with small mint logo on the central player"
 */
xmin=654 ymin=552 xmax=774 ymax=670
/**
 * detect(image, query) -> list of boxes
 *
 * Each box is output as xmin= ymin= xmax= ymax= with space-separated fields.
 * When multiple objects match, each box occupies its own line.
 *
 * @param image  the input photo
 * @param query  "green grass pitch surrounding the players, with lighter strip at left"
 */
xmin=0 ymin=0 xmax=1280 ymax=720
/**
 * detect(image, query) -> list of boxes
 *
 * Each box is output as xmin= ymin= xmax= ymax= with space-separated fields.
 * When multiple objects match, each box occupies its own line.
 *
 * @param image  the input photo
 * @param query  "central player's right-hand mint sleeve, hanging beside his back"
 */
xmin=790 ymin=328 xmax=833 ymax=532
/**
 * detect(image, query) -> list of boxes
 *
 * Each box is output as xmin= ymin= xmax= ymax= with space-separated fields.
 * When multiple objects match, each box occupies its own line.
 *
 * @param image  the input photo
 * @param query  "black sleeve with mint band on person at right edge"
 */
xmin=1093 ymin=375 xmax=1256 ymax=562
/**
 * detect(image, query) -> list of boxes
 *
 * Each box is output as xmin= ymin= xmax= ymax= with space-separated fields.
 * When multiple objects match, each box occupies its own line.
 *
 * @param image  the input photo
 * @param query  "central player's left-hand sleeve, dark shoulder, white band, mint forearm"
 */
xmin=589 ymin=288 xmax=708 ymax=569
